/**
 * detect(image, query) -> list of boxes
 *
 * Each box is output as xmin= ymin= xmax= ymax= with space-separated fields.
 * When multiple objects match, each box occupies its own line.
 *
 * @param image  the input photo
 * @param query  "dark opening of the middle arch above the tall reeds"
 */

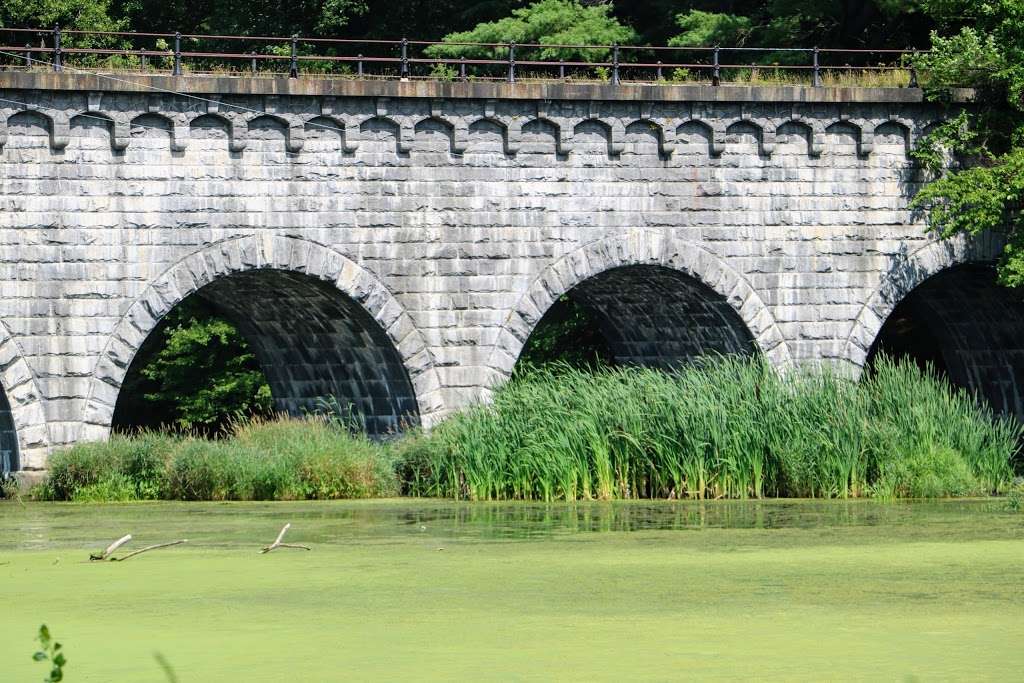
xmin=520 ymin=265 xmax=755 ymax=370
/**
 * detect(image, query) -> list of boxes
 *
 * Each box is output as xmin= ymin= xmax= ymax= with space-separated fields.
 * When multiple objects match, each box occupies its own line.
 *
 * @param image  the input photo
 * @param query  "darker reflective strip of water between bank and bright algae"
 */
xmin=0 ymin=499 xmax=1007 ymax=549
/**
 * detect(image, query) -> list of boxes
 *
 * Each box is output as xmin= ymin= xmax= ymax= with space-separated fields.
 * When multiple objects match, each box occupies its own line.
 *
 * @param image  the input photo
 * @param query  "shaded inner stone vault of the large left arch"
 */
xmin=114 ymin=269 xmax=419 ymax=435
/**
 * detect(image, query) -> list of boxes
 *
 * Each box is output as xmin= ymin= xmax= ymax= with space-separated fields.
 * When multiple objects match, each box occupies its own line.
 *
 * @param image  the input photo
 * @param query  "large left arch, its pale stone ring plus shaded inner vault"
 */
xmin=79 ymin=236 xmax=442 ymax=439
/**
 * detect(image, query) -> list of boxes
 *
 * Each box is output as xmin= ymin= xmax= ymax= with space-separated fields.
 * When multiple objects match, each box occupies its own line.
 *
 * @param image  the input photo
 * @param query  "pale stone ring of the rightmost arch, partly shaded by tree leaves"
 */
xmin=843 ymin=236 xmax=1001 ymax=373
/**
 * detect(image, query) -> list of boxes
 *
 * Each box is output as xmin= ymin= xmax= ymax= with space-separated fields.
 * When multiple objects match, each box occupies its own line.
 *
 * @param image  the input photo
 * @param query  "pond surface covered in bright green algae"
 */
xmin=0 ymin=500 xmax=1024 ymax=681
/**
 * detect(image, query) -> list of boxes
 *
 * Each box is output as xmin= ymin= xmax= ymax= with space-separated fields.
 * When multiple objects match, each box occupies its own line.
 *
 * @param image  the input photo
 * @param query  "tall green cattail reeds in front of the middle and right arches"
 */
xmin=393 ymin=358 xmax=1020 ymax=501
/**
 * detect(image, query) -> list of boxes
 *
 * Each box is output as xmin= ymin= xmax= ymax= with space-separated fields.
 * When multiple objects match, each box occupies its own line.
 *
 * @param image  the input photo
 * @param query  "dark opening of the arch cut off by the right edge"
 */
xmin=867 ymin=265 xmax=1024 ymax=419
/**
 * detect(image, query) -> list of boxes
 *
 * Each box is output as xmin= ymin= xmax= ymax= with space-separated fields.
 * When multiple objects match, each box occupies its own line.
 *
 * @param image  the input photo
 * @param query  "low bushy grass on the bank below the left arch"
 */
xmin=38 ymin=418 xmax=398 ymax=501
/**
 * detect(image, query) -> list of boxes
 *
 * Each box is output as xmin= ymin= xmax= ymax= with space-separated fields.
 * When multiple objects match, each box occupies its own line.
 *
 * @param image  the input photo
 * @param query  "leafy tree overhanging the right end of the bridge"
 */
xmin=912 ymin=0 xmax=1024 ymax=287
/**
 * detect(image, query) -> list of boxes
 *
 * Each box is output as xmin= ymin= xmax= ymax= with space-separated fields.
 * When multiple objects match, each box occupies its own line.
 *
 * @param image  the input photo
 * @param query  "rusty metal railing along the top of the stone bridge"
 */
xmin=0 ymin=27 xmax=918 ymax=87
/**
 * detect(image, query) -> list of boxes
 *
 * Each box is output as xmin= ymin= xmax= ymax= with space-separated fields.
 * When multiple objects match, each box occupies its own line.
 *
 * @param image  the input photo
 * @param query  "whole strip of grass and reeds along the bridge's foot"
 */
xmin=32 ymin=358 xmax=1020 ymax=501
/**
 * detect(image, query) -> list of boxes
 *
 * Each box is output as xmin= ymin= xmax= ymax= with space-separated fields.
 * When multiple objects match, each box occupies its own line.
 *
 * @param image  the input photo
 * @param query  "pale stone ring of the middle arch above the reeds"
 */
xmin=488 ymin=230 xmax=792 ymax=377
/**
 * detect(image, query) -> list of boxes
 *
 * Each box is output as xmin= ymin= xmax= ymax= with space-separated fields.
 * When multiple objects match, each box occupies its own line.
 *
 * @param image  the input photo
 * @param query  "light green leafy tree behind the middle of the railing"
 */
xmin=426 ymin=0 xmax=637 ymax=60
